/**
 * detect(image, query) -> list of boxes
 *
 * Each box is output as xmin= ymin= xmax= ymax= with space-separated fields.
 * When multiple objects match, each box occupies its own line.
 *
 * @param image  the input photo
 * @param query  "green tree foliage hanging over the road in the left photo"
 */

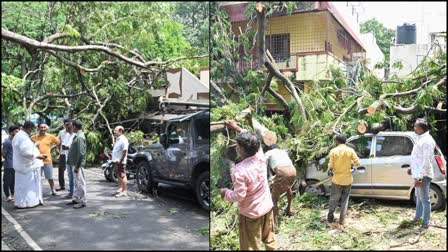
xmin=2 ymin=2 xmax=208 ymax=161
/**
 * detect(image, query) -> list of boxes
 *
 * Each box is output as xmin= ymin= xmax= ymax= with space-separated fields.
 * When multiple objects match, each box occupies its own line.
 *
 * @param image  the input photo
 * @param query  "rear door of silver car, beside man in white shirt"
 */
xmin=372 ymin=135 xmax=414 ymax=198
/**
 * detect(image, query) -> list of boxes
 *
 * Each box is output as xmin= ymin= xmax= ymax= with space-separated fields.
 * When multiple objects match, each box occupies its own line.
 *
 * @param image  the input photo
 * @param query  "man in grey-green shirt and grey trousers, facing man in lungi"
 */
xmin=67 ymin=120 xmax=87 ymax=209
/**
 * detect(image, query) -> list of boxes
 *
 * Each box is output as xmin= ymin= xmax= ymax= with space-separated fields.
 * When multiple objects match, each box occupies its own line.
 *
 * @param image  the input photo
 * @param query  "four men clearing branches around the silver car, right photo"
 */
xmin=220 ymin=119 xmax=436 ymax=250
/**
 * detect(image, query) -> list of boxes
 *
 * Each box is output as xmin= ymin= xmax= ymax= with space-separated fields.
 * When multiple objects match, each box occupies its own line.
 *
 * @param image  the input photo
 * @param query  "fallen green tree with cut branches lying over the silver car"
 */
xmin=211 ymin=3 xmax=447 ymax=249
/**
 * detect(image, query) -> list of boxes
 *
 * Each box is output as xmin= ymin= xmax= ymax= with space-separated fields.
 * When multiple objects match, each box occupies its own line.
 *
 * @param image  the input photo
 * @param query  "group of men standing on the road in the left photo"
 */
xmin=2 ymin=119 xmax=129 ymax=209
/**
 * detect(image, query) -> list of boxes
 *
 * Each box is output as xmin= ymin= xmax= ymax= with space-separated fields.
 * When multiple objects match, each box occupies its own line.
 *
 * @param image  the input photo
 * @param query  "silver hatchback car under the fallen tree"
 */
xmin=301 ymin=131 xmax=446 ymax=210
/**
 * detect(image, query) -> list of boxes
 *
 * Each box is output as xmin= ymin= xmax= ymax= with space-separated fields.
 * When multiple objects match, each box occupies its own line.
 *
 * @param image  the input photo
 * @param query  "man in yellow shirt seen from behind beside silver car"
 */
xmin=327 ymin=134 xmax=360 ymax=225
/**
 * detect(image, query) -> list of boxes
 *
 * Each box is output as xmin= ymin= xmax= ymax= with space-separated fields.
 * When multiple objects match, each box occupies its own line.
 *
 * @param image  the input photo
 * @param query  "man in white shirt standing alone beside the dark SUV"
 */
xmin=112 ymin=126 xmax=129 ymax=198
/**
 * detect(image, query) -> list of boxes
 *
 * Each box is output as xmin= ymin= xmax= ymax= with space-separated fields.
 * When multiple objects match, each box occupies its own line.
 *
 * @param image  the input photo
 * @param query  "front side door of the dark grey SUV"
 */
xmin=161 ymin=121 xmax=191 ymax=181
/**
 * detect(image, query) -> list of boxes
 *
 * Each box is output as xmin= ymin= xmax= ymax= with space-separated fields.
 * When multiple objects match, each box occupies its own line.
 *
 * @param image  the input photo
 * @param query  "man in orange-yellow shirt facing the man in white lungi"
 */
xmin=31 ymin=123 xmax=60 ymax=196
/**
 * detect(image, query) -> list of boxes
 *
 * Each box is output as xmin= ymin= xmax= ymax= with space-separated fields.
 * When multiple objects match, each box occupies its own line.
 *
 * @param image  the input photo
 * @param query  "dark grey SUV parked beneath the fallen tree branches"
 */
xmin=134 ymin=109 xmax=210 ymax=210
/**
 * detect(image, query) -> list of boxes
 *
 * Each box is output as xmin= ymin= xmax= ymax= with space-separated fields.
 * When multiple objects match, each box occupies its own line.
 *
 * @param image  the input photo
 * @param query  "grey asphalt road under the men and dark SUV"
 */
xmin=2 ymin=168 xmax=209 ymax=250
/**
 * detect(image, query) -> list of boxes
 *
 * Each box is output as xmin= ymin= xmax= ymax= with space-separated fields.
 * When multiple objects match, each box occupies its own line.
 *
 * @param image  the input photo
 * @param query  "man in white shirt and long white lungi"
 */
xmin=12 ymin=121 xmax=45 ymax=208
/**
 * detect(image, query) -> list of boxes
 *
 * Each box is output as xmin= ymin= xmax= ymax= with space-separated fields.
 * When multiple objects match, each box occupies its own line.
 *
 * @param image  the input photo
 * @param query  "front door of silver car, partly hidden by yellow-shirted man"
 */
xmin=347 ymin=135 xmax=373 ymax=196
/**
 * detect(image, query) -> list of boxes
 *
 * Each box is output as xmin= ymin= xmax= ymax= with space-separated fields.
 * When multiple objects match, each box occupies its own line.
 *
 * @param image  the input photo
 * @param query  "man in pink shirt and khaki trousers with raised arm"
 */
xmin=221 ymin=120 xmax=276 ymax=250
